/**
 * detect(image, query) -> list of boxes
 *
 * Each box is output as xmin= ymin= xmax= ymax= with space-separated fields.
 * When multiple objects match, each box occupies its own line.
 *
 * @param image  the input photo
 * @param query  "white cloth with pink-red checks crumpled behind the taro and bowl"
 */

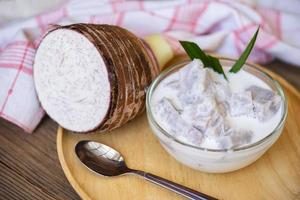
xmin=0 ymin=0 xmax=300 ymax=132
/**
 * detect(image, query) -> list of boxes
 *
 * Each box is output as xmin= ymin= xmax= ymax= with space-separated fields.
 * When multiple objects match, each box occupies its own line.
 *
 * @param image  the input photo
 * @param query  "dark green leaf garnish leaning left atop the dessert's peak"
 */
xmin=179 ymin=41 xmax=227 ymax=80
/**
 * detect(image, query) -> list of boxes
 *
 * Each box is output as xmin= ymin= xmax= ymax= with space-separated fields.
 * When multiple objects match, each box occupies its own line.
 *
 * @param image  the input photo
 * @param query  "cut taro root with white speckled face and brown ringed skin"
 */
xmin=34 ymin=24 xmax=159 ymax=132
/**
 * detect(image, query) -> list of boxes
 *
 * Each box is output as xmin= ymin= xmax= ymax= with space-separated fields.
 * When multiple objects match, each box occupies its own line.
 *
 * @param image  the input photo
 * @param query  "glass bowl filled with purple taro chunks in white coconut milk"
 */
xmin=146 ymin=59 xmax=287 ymax=173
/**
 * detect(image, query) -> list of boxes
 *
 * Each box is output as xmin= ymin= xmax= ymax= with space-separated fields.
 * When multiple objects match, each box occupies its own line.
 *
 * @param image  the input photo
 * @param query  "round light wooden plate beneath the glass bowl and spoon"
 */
xmin=57 ymin=66 xmax=300 ymax=200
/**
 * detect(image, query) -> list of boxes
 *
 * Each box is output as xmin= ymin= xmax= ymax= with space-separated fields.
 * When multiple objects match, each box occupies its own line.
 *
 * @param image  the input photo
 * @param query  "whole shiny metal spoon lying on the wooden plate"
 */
xmin=75 ymin=141 xmax=216 ymax=200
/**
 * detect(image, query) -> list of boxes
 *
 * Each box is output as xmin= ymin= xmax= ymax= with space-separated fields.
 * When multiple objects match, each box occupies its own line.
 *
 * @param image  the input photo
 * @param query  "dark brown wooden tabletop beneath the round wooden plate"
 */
xmin=0 ymin=61 xmax=300 ymax=200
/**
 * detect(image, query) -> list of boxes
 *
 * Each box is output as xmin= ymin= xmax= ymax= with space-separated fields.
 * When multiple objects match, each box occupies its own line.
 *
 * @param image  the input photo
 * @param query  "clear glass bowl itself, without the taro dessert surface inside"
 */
xmin=146 ymin=58 xmax=287 ymax=173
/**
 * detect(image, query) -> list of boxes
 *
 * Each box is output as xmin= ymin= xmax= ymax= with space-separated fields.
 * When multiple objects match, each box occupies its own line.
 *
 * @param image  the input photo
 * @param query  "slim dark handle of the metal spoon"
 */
xmin=144 ymin=173 xmax=217 ymax=200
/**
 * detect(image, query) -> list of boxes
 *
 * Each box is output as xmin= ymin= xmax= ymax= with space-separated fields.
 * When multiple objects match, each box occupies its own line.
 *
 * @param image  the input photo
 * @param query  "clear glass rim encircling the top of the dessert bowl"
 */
xmin=146 ymin=57 xmax=288 ymax=152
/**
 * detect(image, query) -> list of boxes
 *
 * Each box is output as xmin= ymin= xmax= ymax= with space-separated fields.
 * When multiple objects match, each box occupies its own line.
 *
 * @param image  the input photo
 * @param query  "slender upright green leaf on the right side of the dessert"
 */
xmin=229 ymin=27 xmax=259 ymax=73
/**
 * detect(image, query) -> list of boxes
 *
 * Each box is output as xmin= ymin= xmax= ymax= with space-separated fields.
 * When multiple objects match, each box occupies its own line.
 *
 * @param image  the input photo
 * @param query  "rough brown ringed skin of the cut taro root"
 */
xmin=52 ymin=24 xmax=159 ymax=132
